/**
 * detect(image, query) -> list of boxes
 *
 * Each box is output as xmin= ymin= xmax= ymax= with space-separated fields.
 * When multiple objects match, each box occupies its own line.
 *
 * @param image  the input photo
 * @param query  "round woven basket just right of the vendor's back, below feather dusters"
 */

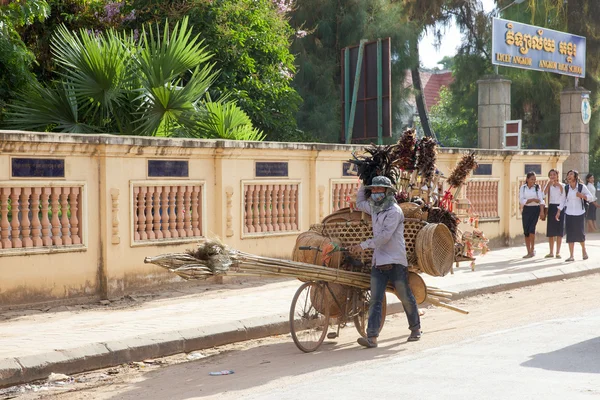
xmin=415 ymin=224 xmax=454 ymax=276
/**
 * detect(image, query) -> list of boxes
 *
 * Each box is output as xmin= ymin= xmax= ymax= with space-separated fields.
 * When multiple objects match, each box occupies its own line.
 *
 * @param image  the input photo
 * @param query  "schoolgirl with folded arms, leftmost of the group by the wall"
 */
xmin=519 ymin=172 xmax=544 ymax=258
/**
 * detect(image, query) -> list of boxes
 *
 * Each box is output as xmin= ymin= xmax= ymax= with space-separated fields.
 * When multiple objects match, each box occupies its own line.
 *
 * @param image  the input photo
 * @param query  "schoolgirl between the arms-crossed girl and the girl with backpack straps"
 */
xmin=544 ymin=169 xmax=565 ymax=258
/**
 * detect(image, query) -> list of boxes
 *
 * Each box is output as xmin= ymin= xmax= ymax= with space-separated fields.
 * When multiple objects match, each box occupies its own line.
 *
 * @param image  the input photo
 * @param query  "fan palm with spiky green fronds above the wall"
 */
xmin=8 ymin=18 xmax=261 ymax=139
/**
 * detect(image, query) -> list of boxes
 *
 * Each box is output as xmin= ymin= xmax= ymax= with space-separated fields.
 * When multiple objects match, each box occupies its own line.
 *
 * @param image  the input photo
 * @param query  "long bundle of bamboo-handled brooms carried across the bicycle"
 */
xmin=144 ymin=241 xmax=468 ymax=314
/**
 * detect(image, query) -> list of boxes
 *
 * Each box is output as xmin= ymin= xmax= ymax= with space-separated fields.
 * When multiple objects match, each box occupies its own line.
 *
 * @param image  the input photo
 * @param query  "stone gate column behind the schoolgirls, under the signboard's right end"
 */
xmin=560 ymin=87 xmax=590 ymax=177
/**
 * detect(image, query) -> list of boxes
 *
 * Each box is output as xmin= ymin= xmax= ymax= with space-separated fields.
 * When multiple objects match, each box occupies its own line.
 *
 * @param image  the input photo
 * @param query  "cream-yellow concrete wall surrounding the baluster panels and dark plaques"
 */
xmin=0 ymin=131 xmax=568 ymax=305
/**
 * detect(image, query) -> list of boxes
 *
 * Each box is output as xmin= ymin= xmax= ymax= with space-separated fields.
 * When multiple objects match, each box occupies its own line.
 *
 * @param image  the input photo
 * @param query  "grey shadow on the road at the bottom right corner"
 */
xmin=521 ymin=337 xmax=600 ymax=374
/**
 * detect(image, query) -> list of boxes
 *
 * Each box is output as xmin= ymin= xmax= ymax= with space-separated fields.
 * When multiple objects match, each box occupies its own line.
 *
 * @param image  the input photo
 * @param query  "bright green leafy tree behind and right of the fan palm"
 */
xmin=127 ymin=0 xmax=302 ymax=140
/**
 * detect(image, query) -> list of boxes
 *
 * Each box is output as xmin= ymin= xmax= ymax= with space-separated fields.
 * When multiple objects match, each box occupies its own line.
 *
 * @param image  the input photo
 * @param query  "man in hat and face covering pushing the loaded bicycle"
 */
xmin=350 ymin=176 xmax=421 ymax=348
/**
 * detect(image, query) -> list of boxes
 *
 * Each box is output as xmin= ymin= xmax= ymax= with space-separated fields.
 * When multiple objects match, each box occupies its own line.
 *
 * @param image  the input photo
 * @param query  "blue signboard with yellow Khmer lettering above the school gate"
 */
xmin=492 ymin=18 xmax=586 ymax=78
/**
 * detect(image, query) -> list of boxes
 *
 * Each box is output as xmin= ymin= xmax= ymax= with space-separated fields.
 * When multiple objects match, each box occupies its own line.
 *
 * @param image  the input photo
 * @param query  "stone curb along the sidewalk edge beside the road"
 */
xmin=0 ymin=264 xmax=600 ymax=387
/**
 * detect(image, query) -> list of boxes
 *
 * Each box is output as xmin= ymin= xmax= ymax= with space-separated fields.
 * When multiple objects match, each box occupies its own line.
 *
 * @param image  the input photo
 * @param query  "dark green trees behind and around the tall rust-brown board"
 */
xmin=291 ymin=0 xmax=414 ymax=142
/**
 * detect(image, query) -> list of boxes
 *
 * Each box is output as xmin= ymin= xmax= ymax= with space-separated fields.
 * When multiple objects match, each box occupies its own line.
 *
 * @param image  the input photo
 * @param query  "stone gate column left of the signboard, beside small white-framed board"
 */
xmin=477 ymin=75 xmax=512 ymax=149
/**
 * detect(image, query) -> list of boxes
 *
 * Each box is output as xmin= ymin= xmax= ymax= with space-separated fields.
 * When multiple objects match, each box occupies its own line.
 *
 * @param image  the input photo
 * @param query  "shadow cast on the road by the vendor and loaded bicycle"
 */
xmin=104 ymin=336 xmax=411 ymax=400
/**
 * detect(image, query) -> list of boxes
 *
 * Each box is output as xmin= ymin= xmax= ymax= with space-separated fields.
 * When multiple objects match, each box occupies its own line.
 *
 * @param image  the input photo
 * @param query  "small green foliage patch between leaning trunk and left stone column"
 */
xmin=429 ymin=87 xmax=477 ymax=147
